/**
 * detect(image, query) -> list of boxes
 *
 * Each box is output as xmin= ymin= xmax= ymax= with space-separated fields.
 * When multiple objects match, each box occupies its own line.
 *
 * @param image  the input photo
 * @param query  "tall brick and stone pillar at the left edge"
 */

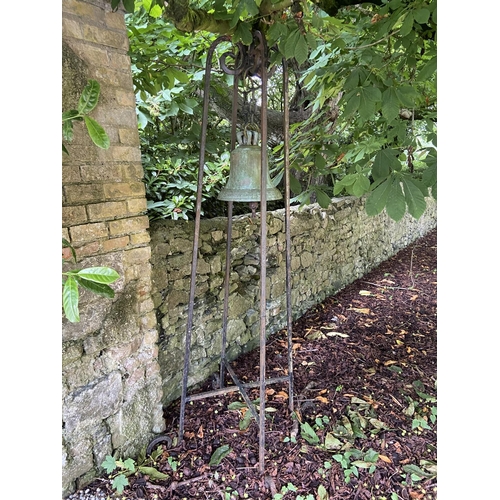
xmin=62 ymin=0 xmax=164 ymax=494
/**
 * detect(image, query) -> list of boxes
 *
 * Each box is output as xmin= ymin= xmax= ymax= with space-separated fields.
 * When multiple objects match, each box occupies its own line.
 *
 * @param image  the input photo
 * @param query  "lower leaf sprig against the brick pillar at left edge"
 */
xmin=62 ymin=238 xmax=120 ymax=323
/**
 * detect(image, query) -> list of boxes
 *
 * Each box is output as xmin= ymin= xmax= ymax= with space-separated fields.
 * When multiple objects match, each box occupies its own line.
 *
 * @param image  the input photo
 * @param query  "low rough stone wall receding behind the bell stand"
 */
xmin=150 ymin=193 xmax=437 ymax=405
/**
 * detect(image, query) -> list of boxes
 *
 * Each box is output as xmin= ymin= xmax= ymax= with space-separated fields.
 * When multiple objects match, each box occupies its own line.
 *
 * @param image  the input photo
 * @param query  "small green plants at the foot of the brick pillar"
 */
xmin=101 ymin=446 xmax=170 ymax=494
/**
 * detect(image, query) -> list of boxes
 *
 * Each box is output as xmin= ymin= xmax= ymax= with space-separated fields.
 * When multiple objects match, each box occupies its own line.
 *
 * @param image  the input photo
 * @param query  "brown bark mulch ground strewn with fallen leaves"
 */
xmin=80 ymin=230 xmax=437 ymax=500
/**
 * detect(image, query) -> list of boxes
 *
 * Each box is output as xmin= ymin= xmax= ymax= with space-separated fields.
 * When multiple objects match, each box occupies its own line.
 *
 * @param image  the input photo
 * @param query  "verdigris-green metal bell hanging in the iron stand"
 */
xmin=218 ymin=145 xmax=282 ymax=202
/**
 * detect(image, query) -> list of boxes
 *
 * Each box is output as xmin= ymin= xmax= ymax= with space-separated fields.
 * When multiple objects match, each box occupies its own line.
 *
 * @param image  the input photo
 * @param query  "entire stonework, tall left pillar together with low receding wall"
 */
xmin=61 ymin=0 xmax=436 ymax=496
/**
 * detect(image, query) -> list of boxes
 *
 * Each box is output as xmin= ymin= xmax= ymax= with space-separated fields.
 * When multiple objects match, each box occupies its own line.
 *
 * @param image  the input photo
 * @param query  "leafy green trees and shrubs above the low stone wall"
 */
xmin=126 ymin=0 xmax=437 ymax=220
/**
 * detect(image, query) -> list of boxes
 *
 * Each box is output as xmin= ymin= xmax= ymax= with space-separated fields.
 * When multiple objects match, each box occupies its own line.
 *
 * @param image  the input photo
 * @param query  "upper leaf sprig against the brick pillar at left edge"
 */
xmin=62 ymin=80 xmax=109 ymax=154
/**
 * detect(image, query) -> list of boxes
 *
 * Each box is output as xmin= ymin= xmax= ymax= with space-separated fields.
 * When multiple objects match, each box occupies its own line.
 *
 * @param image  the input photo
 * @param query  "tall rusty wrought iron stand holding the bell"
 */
xmin=179 ymin=31 xmax=294 ymax=473
